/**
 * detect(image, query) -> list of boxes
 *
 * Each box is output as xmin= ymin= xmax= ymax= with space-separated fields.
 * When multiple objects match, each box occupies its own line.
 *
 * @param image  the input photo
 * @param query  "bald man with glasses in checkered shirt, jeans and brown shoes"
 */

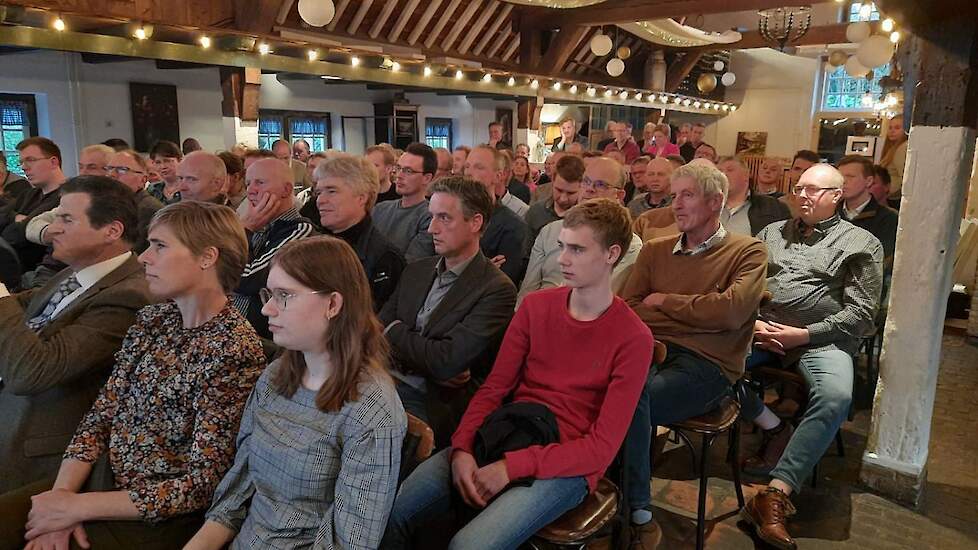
xmin=741 ymin=164 xmax=883 ymax=548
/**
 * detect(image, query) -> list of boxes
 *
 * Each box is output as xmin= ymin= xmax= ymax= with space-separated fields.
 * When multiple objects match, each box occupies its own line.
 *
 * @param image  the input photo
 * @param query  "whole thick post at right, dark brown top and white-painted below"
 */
xmin=860 ymin=12 xmax=978 ymax=505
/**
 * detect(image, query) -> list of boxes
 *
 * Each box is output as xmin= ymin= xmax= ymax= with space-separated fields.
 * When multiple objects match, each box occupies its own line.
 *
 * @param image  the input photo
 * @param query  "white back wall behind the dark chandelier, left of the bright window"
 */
xmin=706 ymin=49 xmax=821 ymax=158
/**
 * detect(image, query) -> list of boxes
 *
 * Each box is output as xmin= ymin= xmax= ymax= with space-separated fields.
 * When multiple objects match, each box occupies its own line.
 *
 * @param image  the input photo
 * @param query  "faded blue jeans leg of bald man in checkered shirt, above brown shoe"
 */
xmin=771 ymin=349 xmax=853 ymax=492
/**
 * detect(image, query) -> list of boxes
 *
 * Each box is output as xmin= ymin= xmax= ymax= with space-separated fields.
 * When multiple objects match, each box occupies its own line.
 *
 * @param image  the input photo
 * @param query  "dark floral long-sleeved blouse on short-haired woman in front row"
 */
xmin=64 ymin=302 xmax=265 ymax=522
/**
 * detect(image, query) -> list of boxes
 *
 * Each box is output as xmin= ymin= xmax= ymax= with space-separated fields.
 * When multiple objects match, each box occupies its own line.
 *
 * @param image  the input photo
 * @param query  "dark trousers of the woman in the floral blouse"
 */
xmin=0 ymin=479 xmax=204 ymax=550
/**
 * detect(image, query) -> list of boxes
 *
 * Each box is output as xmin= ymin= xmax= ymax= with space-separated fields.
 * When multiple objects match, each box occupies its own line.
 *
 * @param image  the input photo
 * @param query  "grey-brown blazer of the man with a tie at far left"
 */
xmin=0 ymin=255 xmax=151 ymax=494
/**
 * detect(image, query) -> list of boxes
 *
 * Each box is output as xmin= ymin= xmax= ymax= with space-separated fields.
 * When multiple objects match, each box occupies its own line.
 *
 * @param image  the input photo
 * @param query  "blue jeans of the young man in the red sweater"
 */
xmin=380 ymin=448 xmax=589 ymax=550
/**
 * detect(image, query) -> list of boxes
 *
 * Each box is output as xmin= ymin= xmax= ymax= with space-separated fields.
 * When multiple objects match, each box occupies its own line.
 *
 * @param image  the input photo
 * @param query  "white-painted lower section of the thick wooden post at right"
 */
xmin=860 ymin=126 xmax=976 ymax=504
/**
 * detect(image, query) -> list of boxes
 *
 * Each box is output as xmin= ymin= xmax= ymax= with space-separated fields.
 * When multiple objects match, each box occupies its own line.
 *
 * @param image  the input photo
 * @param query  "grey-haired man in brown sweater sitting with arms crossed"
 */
xmin=622 ymin=164 xmax=767 ymax=548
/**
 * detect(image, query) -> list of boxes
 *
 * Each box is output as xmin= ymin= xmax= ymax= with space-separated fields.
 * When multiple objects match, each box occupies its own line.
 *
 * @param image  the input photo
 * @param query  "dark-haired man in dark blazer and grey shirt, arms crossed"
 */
xmin=380 ymin=176 xmax=516 ymax=442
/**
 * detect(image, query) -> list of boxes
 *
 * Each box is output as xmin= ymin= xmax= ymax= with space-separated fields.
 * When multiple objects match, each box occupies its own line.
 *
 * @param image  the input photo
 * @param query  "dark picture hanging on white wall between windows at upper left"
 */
xmin=129 ymin=82 xmax=180 ymax=153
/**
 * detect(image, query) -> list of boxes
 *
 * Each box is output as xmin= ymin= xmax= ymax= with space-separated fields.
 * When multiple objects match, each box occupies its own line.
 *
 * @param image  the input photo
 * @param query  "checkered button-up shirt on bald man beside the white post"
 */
xmin=757 ymin=215 xmax=883 ymax=353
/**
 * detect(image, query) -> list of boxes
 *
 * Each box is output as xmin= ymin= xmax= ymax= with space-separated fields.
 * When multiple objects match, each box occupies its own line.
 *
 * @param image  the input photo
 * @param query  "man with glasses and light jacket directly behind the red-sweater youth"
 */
xmin=517 ymin=157 xmax=642 ymax=306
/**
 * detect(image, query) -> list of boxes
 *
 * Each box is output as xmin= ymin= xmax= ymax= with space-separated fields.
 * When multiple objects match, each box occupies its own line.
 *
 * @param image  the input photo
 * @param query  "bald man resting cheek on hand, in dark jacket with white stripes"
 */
xmin=231 ymin=157 xmax=315 ymax=339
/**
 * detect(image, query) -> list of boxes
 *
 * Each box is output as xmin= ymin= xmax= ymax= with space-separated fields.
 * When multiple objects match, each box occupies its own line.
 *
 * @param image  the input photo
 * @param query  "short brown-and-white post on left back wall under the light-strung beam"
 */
xmin=221 ymin=67 xmax=261 ymax=149
